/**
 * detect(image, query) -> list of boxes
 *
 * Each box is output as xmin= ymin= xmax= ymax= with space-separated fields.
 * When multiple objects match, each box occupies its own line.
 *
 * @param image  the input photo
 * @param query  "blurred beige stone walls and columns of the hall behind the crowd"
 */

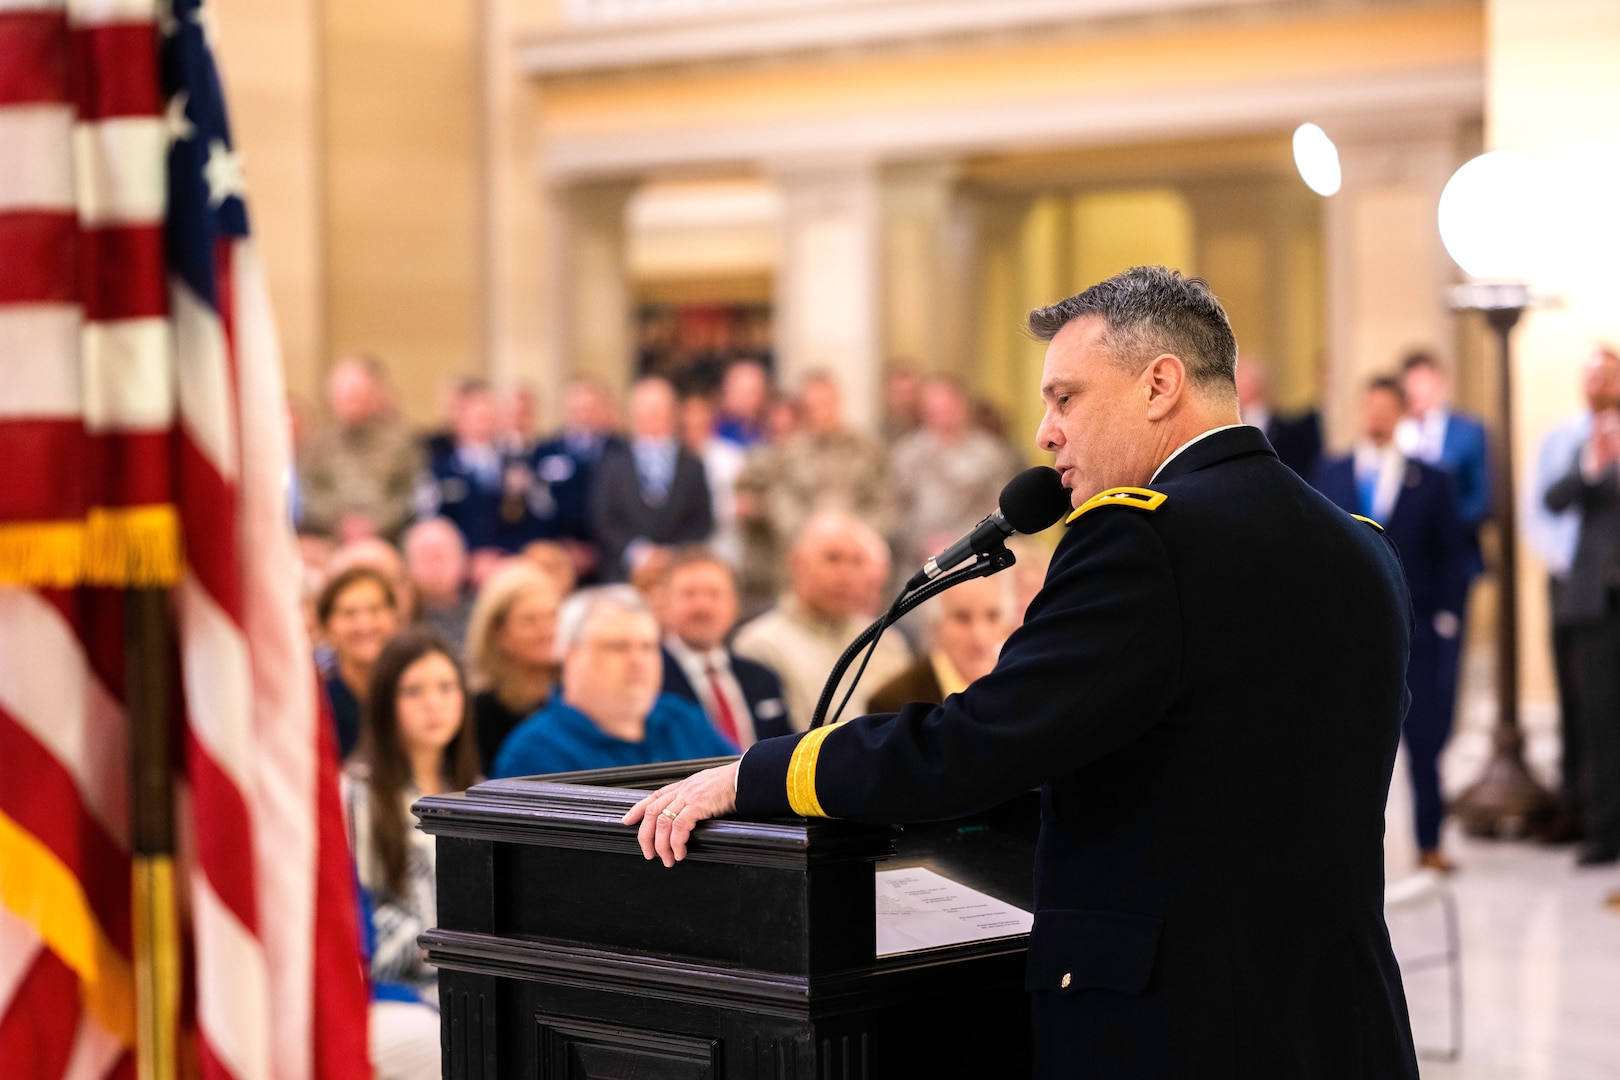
xmin=219 ymin=0 xmax=1620 ymax=712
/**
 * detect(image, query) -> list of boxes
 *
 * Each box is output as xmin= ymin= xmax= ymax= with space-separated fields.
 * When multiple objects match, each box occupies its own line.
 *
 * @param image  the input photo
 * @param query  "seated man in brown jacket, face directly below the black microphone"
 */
xmin=867 ymin=575 xmax=1017 ymax=712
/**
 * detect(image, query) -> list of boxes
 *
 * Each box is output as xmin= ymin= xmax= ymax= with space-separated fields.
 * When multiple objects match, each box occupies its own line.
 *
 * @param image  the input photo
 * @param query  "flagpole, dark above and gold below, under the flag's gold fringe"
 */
xmin=123 ymin=588 xmax=180 ymax=1080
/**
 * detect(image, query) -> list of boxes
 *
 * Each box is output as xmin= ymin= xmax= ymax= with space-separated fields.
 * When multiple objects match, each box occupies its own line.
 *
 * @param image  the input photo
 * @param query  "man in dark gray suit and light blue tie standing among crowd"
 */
xmin=591 ymin=376 xmax=714 ymax=581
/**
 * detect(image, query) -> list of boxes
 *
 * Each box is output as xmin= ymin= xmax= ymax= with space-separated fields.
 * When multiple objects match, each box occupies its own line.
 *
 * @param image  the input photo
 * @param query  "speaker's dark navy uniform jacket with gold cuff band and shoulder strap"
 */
xmin=737 ymin=427 xmax=1418 ymax=1080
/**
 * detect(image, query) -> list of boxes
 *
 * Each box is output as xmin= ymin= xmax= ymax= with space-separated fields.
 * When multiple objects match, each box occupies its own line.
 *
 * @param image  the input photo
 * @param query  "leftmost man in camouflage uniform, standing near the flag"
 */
xmin=296 ymin=356 xmax=421 ymax=541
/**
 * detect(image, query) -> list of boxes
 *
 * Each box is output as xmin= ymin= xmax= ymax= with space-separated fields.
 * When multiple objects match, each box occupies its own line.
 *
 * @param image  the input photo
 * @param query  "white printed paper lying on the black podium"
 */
xmin=876 ymin=866 xmax=1035 ymax=957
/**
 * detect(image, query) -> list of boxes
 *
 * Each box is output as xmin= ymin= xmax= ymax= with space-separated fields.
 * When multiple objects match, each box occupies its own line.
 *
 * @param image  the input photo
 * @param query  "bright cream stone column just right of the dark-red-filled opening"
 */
xmin=771 ymin=162 xmax=881 ymax=431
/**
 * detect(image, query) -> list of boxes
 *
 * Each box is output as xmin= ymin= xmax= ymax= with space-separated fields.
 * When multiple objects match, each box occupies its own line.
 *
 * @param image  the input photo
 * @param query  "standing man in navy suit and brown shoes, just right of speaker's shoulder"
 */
xmin=1315 ymin=379 xmax=1469 ymax=871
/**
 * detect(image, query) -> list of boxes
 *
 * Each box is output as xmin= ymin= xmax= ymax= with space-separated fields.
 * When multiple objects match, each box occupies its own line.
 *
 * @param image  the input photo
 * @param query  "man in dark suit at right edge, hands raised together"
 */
xmin=1544 ymin=365 xmax=1620 ymax=866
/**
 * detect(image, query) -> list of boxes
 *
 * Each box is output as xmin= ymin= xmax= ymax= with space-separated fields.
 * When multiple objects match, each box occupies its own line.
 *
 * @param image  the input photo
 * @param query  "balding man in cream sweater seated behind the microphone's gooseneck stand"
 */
xmin=732 ymin=512 xmax=910 ymax=730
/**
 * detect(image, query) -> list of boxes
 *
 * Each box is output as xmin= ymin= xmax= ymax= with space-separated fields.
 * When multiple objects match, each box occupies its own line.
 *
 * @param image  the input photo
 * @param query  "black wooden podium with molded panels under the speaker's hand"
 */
xmin=416 ymin=759 xmax=1038 ymax=1080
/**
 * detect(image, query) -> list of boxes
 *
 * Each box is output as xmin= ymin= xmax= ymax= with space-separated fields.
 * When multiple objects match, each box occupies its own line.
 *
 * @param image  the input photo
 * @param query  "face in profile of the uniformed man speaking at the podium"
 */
xmin=1035 ymin=316 xmax=1157 ymax=507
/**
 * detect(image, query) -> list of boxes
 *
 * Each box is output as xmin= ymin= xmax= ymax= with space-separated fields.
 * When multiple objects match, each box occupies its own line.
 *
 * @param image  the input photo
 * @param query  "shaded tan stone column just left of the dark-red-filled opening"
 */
xmin=541 ymin=183 xmax=635 ymax=402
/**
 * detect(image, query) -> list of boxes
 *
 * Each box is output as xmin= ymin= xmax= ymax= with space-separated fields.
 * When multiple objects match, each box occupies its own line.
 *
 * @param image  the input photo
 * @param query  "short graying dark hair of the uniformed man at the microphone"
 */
xmin=1029 ymin=266 xmax=1238 ymax=395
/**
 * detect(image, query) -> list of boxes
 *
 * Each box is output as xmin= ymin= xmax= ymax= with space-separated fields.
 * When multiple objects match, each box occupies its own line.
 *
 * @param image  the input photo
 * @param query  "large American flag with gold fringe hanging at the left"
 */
xmin=0 ymin=0 xmax=369 ymax=1080
